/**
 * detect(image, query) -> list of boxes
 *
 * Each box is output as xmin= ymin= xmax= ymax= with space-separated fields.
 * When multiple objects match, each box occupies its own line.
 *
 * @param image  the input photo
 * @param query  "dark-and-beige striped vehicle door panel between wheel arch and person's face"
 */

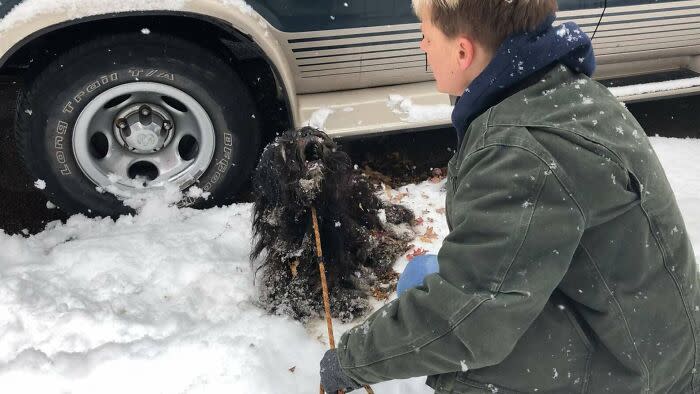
xmin=251 ymin=0 xmax=422 ymax=93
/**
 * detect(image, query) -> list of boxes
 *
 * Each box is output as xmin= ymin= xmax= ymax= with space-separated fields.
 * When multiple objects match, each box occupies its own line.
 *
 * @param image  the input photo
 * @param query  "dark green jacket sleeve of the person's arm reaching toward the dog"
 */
xmin=338 ymin=145 xmax=584 ymax=384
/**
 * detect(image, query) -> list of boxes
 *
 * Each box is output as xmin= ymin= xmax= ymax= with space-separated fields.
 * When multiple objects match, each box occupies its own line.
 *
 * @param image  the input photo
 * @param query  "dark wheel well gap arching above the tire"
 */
xmin=0 ymin=13 xmax=293 ymax=146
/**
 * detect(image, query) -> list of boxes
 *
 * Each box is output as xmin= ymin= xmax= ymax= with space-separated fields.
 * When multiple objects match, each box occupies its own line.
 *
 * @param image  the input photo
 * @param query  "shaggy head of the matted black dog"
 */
xmin=254 ymin=127 xmax=351 ymax=211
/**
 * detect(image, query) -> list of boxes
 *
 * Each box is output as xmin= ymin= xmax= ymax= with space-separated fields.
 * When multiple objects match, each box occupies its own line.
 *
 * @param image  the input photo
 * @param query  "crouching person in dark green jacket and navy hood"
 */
xmin=321 ymin=0 xmax=700 ymax=394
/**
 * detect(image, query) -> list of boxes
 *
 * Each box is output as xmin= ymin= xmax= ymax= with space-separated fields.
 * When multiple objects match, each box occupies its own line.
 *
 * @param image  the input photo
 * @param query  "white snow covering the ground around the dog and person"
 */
xmin=0 ymin=138 xmax=700 ymax=394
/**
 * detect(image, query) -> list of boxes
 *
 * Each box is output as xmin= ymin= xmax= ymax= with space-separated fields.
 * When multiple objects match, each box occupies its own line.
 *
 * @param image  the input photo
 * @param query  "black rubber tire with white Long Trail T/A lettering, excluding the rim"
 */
xmin=26 ymin=37 xmax=259 ymax=215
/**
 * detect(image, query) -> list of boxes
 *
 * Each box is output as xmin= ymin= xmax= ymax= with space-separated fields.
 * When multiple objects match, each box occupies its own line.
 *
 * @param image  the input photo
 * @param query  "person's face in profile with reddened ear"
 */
xmin=420 ymin=7 xmax=483 ymax=96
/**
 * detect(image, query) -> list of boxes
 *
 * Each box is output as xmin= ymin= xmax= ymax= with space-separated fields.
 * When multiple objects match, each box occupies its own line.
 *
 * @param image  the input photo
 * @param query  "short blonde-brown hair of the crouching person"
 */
xmin=412 ymin=0 xmax=558 ymax=50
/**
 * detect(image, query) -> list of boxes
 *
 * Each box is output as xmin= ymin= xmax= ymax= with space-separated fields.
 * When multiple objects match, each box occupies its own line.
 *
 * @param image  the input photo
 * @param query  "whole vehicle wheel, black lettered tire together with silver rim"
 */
xmin=16 ymin=34 xmax=260 ymax=216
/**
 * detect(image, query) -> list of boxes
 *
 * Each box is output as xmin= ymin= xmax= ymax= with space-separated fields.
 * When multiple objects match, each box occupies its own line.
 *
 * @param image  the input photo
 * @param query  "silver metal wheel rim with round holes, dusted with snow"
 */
xmin=73 ymin=82 xmax=216 ymax=198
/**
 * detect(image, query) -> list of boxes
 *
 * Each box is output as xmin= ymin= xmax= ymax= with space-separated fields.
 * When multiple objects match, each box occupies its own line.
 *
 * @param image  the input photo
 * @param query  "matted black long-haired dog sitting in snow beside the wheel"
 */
xmin=251 ymin=127 xmax=414 ymax=321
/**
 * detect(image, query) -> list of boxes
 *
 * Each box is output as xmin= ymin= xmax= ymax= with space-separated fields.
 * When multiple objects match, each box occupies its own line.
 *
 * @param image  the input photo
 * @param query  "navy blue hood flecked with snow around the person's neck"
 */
xmin=452 ymin=15 xmax=595 ymax=146
